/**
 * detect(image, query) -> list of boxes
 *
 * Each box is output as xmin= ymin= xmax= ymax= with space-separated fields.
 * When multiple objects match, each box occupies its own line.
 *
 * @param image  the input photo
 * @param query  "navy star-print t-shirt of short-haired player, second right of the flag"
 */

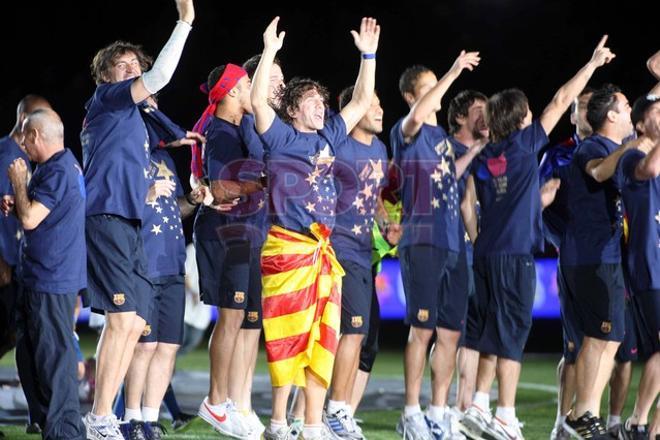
xmin=390 ymin=118 xmax=462 ymax=252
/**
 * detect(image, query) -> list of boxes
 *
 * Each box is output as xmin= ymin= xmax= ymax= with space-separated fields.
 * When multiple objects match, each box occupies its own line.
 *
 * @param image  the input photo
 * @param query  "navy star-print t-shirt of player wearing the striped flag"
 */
xmin=261 ymin=114 xmax=348 ymax=233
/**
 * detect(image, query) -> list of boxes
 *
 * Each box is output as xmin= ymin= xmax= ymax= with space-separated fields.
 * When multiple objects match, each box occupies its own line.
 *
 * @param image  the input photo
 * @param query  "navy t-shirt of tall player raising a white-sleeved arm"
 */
xmin=80 ymin=80 xmax=149 ymax=220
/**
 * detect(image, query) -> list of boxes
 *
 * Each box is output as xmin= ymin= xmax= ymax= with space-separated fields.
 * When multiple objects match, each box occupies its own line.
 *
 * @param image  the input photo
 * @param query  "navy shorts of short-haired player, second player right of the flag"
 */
xmin=399 ymin=245 xmax=467 ymax=331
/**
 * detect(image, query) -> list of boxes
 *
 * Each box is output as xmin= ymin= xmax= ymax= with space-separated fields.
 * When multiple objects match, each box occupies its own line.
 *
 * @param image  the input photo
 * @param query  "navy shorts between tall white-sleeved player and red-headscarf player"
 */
xmin=140 ymin=275 xmax=186 ymax=345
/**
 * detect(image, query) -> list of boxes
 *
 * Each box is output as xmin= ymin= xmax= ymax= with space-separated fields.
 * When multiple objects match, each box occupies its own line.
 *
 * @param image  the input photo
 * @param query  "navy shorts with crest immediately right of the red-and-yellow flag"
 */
xmin=339 ymin=260 xmax=373 ymax=335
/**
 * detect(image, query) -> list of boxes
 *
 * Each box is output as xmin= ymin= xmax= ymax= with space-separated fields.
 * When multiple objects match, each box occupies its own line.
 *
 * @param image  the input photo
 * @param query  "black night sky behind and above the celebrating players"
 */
xmin=0 ymin=0 xmax=660 ymax=350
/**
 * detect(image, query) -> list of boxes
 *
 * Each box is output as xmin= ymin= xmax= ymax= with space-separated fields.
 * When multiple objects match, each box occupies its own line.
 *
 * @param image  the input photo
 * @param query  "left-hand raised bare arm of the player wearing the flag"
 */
xmin=250 ymin=17 xmax=285 ymax=134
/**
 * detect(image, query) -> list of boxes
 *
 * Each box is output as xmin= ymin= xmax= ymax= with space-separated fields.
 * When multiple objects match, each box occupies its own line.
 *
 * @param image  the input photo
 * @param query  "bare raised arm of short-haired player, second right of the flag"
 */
xmin=401 ymin=50 xmax=481 ymax=138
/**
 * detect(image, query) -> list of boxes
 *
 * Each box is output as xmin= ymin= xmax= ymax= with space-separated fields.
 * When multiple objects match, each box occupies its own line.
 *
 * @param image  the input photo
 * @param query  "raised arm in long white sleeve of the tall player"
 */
xmin=131 ymin=0 xmax=195 ymax=103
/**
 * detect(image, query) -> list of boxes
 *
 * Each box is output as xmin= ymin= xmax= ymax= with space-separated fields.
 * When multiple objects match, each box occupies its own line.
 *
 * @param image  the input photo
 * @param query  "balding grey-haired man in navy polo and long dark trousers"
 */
xmin=3 ymin=109 xmax=87 ymax=440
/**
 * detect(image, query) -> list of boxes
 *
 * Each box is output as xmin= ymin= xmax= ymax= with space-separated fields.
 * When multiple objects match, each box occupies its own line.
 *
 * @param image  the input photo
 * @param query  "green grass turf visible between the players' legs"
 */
xmin=0 ymin=334 xmax=641 ymax=440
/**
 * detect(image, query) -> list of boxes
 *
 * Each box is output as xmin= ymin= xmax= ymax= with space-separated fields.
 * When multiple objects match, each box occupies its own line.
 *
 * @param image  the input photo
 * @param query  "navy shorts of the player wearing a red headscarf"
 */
xmin=195 ymin=238 xmax=250 ymax=310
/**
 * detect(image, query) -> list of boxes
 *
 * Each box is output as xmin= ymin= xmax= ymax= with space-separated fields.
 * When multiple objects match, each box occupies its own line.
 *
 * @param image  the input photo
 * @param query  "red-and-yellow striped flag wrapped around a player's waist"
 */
xmin=261 ymin=223 xmax=344 ymax=388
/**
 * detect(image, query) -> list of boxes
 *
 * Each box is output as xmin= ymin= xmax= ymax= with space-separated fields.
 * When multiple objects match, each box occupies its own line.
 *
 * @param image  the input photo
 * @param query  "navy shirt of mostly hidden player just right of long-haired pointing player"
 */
xmin=539 ymin=134 xmax=580 ymax=249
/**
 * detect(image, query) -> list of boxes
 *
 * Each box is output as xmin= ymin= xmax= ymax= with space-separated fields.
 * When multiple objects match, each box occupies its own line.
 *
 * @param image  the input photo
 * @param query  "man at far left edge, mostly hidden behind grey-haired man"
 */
xmin=0 ymin=95 xmax=50 ymax=357
